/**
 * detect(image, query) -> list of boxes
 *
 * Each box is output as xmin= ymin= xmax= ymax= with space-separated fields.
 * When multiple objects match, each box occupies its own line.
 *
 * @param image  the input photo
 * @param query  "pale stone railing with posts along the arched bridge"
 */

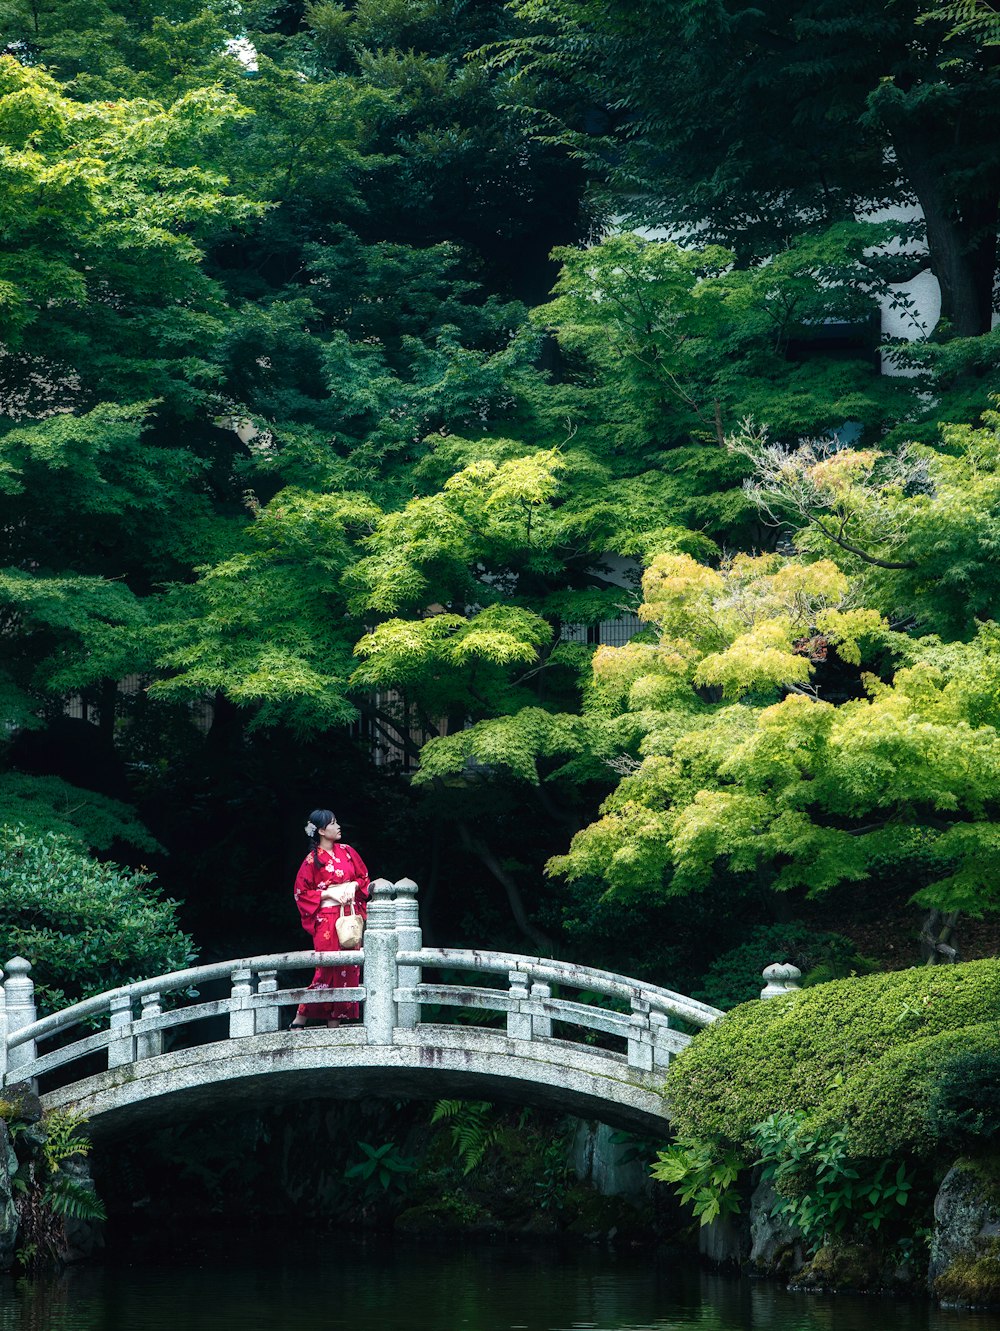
xmin=0 ymin=878 xmax=722 ymax=1085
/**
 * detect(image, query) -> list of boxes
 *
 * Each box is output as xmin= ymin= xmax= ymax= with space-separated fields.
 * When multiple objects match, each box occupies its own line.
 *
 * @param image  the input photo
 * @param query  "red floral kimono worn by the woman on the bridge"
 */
xmin=296 ymin=841 xmax=369 ymax=1021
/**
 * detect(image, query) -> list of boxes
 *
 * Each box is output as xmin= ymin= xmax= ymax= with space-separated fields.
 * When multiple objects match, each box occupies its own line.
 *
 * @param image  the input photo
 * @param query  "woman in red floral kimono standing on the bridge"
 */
xmin=289 ymin=809 xmax=369 ymax=1030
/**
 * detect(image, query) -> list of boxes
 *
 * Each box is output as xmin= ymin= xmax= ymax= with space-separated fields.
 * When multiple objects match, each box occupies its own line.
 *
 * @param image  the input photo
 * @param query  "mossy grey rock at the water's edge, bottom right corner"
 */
xmin=927 ymin=1161 xmax=1000 ymax=1307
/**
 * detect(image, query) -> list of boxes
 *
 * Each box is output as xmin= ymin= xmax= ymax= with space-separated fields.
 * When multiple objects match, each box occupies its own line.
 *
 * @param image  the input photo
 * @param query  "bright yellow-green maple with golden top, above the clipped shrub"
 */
xmin=550 ymin=555 xmax=1000 ymax=937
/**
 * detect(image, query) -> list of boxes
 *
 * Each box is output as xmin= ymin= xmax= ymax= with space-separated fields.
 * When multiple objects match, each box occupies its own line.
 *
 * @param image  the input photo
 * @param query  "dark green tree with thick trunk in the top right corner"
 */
xmin=495 ymin=0 xmax=1000 ymax=335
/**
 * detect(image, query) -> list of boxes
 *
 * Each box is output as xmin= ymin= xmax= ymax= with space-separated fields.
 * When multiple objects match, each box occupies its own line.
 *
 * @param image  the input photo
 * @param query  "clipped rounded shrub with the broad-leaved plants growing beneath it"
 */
xmin=652 ymin=960 xmax=1000 ymax=1252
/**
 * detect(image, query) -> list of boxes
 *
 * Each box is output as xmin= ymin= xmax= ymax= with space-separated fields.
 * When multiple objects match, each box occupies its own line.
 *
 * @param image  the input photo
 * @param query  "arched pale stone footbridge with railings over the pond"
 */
xmin=0 ymin=878 xmax=745 ymax=1138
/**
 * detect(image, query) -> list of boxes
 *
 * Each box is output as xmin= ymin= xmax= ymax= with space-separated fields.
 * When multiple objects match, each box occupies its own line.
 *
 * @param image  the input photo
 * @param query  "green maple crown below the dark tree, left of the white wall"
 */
xmin=533 ymin=230 xmax=915 ymax=489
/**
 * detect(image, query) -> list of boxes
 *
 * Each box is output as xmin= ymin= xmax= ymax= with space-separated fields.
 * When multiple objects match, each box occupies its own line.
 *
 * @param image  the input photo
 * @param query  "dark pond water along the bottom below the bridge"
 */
xmin=0 ymin=1235 xmax=1000 ymax=1331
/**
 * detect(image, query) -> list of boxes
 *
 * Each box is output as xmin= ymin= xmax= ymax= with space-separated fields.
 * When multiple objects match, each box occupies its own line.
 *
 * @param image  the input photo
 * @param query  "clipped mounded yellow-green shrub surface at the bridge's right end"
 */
xmin=667 ymin=960 xmax=1000 ymax=1155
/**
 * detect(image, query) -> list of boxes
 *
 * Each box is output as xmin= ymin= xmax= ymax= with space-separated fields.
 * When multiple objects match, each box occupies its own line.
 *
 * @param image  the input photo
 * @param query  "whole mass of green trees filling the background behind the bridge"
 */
xmin=0 ymin=0 xmax=1000 ymax=998
